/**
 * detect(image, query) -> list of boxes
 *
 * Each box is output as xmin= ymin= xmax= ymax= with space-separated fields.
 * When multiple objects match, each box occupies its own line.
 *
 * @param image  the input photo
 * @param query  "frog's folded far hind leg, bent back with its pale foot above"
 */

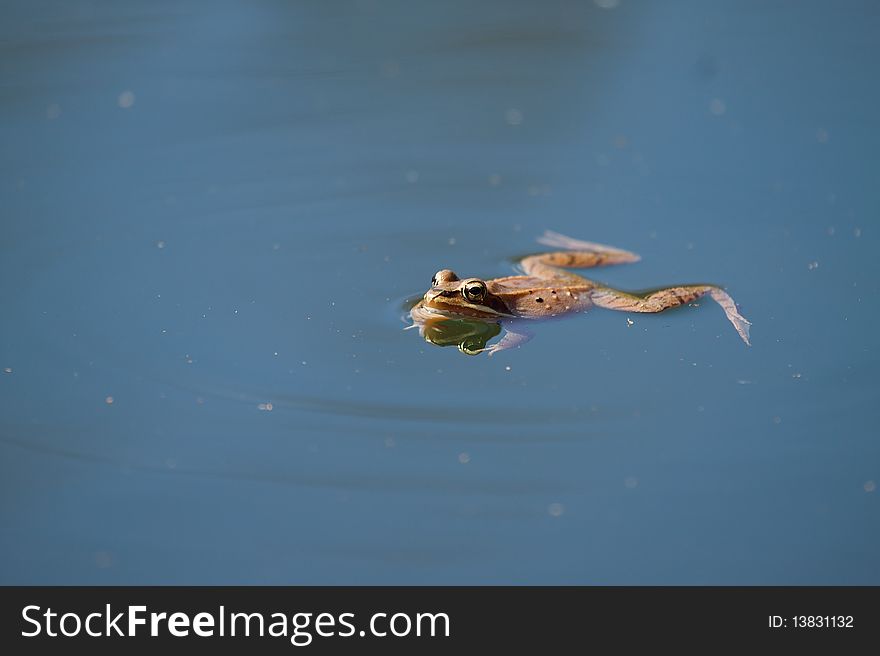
xmin=520 ymin=230 xmax=641 ymax=279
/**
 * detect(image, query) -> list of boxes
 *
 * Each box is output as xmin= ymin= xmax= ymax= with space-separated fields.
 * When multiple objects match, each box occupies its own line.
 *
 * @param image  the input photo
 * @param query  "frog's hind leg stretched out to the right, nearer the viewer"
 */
xmin=591 ymin=285 xmax=752 ymax=346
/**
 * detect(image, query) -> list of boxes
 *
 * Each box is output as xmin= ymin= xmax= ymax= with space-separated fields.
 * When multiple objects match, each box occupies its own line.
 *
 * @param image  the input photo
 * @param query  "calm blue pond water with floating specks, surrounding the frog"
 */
xmin=0 ymin=0 xmax=880 ymax=584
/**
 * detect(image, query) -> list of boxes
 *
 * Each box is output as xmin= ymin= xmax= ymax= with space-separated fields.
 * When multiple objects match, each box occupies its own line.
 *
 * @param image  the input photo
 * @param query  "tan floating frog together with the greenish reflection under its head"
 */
xmin=410 ymin=232 xmax=751 ymax=355
